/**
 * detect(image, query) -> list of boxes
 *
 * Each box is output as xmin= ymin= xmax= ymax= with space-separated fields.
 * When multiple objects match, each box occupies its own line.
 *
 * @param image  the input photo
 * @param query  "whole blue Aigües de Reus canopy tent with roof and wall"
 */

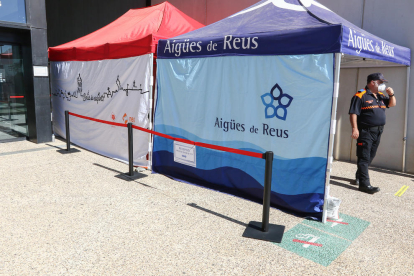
xmin=152 ymin=0 xmax=410 ymax=222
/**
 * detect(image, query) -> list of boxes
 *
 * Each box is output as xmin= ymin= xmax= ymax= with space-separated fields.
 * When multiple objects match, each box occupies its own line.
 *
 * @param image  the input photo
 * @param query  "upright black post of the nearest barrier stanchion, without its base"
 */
xmin=262 ymin=151 xmax=273 ymax=232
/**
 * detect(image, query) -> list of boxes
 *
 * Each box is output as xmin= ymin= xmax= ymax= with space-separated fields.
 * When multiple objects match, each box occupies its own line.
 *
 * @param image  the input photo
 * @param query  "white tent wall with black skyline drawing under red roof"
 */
xmin=51 ymin=55 xmax=152 ymax=165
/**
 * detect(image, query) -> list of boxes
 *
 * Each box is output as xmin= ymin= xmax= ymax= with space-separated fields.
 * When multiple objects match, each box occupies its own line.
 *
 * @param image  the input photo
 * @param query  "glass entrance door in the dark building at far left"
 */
xmin=0 ymin=43 xmax=28 ymax=142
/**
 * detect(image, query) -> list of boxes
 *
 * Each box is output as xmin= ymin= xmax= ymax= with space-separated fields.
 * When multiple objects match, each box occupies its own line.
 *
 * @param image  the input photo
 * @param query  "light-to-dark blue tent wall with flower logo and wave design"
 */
xmin=153 ymin=54 xmax=334 ymax=218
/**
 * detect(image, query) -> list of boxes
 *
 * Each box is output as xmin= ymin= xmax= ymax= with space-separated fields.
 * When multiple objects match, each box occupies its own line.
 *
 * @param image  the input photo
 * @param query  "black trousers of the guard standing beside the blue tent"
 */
xmin=356 ymin=126 xmax=384 ymax=186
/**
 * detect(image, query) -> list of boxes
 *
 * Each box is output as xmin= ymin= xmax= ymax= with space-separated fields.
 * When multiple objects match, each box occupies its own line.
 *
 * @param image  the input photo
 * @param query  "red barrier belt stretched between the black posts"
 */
xmin=69 ymin=112 xmax=263 ymax=159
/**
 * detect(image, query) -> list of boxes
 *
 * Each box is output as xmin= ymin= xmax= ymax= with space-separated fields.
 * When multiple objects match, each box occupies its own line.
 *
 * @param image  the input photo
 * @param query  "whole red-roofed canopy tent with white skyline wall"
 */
xmin=49 ymin=2 xmax=204 ymax=169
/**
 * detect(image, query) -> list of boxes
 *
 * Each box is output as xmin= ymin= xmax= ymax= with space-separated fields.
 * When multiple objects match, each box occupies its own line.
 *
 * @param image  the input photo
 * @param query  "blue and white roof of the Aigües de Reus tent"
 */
xmin=158 ymin=0 xmax=410 ymax=65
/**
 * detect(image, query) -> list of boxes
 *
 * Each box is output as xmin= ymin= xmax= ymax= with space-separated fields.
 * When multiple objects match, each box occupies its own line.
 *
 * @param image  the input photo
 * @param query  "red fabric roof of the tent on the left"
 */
xmin=49 ymin=2 xmax=204 ymax=61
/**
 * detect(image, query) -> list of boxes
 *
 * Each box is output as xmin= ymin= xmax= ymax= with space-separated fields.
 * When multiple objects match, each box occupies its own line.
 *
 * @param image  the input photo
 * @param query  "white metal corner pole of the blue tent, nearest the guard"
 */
xmin=322 ymin=53 xmax=342 ymax=223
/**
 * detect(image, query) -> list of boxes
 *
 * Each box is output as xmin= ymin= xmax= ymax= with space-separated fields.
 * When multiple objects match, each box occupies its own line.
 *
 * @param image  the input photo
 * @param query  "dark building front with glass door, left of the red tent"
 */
xmin=0 ymin=0 xmax=52 ymax=143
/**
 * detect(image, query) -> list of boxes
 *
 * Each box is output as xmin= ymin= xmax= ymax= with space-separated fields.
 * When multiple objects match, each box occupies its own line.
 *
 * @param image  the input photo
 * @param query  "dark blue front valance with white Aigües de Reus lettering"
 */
xmin=158 ymin=25 xmax=342 ymax=59
